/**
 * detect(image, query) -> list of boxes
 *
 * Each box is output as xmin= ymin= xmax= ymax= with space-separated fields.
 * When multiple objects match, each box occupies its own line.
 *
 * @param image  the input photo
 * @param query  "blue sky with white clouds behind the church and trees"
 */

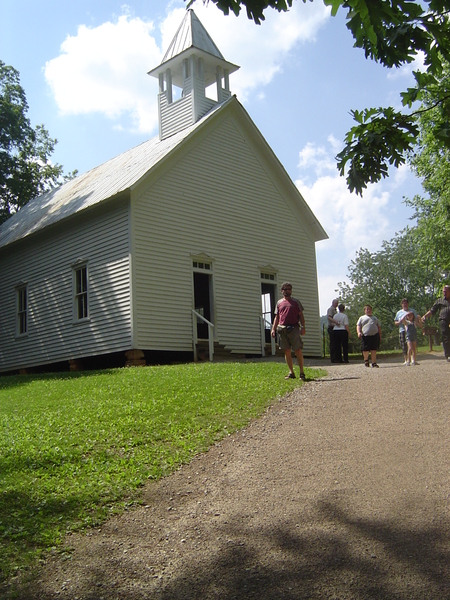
xmin=0 ymin=0 xmax=422 ymax=315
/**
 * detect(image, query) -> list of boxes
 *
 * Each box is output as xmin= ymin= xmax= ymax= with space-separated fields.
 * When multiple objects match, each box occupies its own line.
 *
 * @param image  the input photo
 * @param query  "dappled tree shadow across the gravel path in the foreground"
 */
xmin=11 ymin=497 xmax=450 ymax=600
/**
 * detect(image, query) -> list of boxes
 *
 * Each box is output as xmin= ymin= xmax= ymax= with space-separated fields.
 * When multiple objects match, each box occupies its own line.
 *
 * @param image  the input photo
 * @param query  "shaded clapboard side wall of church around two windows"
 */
xmin=0 ymin=203 xmax=131 ymax=371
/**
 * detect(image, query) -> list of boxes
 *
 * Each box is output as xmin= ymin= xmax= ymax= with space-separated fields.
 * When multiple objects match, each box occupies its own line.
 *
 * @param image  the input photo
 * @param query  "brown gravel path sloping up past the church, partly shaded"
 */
xmin=6 ymin=355 xmax=450 ymax=600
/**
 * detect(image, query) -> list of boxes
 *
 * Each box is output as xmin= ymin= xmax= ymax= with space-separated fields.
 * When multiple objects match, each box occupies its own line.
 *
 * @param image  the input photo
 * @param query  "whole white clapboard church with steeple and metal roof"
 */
xmin=0 ymin=10 xmax=327 ymax=373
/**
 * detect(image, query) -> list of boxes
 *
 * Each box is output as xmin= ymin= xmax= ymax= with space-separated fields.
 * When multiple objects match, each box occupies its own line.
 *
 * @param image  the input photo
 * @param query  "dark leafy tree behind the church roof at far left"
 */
xmin=0 ymin=61 xmax=76 ymax=223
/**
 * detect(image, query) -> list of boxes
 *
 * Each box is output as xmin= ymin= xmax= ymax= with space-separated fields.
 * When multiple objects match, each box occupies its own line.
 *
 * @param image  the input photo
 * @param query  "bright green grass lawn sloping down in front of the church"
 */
xmin=0 ymin=361 xmax=323 ymax=580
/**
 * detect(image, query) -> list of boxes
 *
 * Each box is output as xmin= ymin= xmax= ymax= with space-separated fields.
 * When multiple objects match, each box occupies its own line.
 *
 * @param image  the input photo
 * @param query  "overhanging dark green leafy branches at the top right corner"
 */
xmin=188 ymin=0 xmax=450 ymax=195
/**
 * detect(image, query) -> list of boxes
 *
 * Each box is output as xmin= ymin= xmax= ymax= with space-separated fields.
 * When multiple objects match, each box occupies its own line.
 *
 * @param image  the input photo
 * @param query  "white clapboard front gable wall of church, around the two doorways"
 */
xmin=132 ymin=118 xmax=321 ymax=355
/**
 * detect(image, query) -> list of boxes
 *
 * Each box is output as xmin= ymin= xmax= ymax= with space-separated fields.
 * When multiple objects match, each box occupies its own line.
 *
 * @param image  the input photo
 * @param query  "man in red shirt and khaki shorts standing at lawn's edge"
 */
xmin=271 ymin=281 xmax=306 ymax=381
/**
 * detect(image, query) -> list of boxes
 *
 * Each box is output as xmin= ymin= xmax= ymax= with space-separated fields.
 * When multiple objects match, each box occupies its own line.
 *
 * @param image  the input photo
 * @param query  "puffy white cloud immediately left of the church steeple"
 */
xmin=45 ymin=15 xmax=161 ymax=131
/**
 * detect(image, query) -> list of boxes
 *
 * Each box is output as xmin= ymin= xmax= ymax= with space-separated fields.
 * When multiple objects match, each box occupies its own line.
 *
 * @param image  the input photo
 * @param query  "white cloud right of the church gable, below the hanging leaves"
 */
xmin=295 ymin=136 xmax=418 ymax=314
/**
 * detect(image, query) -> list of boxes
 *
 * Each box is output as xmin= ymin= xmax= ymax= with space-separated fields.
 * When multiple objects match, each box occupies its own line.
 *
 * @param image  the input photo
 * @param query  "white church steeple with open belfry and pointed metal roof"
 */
xmin=149 ymin=9 xmax=239 ymax=140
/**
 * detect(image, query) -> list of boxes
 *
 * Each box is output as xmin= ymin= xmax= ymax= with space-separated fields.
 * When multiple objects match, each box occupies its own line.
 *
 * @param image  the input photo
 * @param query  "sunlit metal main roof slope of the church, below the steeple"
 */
xmin=0 ymin=102 xmax=227 ymax=248
